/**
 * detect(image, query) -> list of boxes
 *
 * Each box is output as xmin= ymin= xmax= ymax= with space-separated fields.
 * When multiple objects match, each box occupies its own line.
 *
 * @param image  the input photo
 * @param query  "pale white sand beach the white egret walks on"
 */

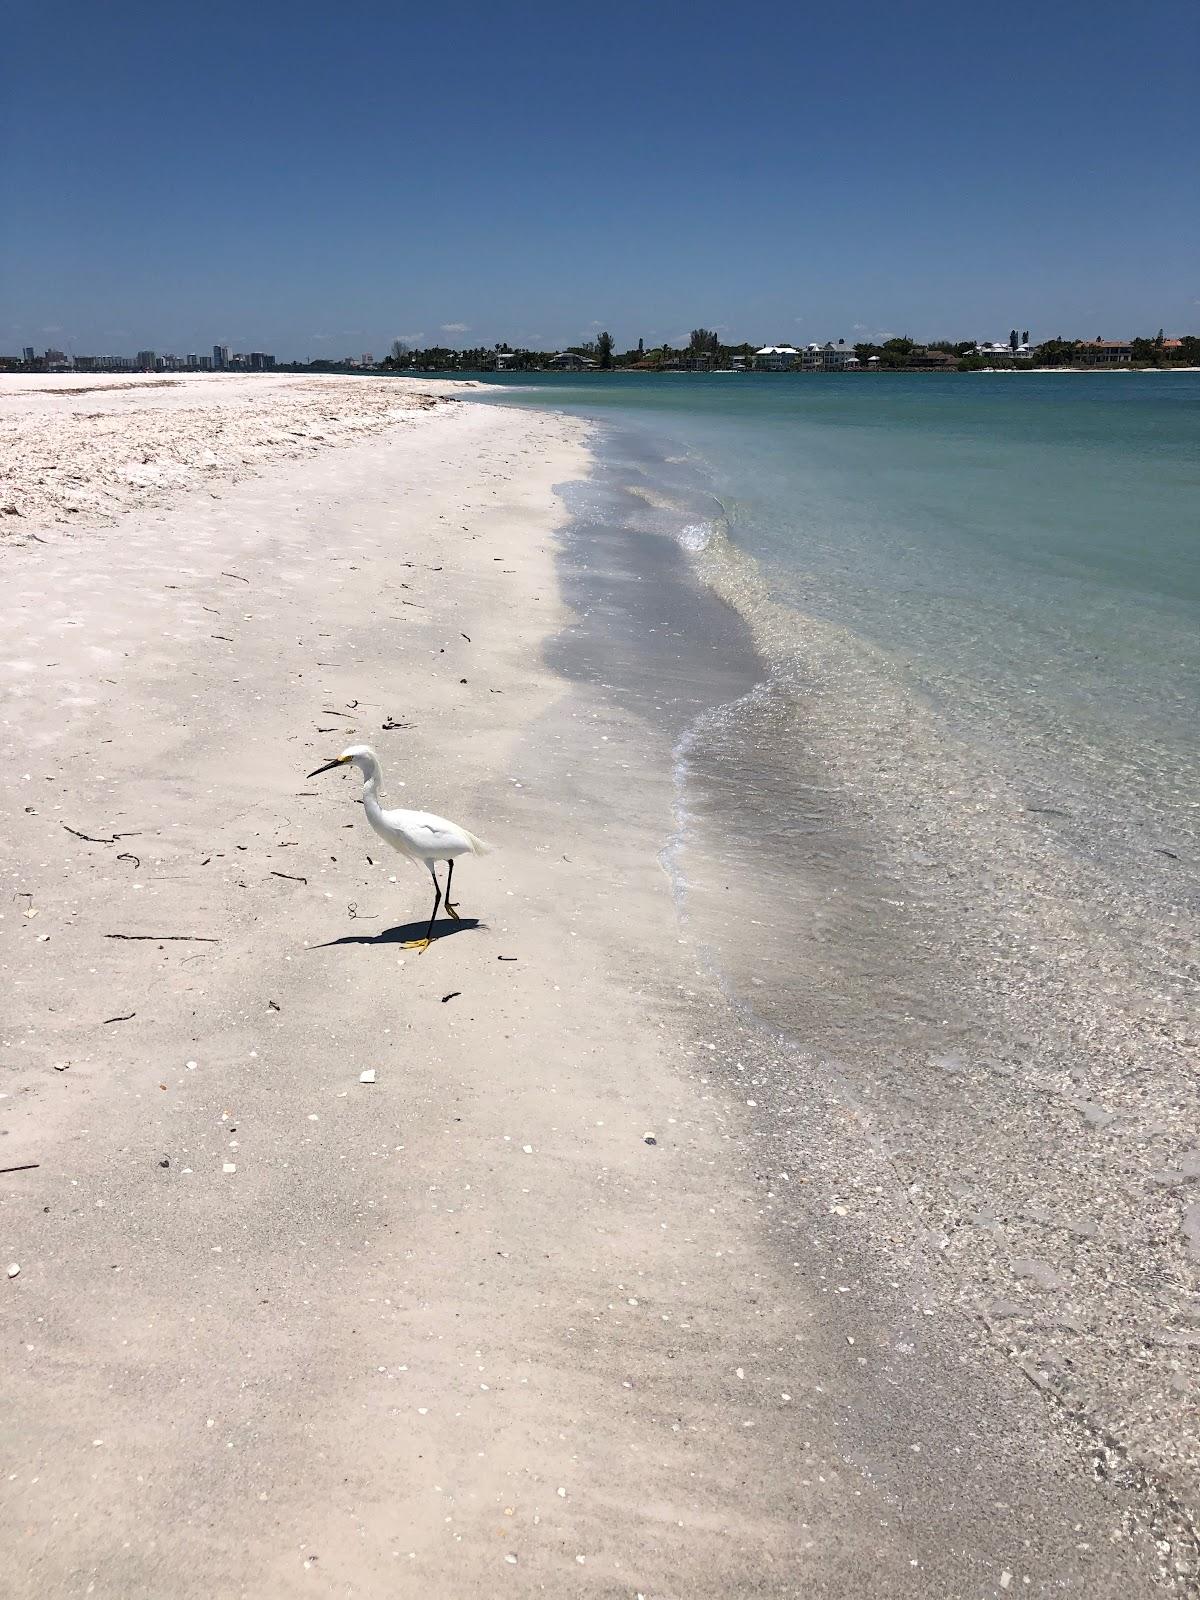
xmin=0 ymin=379 xmax=1196 ymax=1600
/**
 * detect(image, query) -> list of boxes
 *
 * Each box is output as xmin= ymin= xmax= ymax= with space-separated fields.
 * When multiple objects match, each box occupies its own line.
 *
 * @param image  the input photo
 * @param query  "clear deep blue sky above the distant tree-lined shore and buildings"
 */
xmin=0 ymin=0 xmax=1200 ymax=357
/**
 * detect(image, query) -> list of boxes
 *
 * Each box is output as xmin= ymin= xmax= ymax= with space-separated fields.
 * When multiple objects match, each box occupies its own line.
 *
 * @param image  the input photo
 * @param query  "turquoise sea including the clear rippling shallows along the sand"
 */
xmin=460 ymin=374 xmax=1200 ymax=1483
